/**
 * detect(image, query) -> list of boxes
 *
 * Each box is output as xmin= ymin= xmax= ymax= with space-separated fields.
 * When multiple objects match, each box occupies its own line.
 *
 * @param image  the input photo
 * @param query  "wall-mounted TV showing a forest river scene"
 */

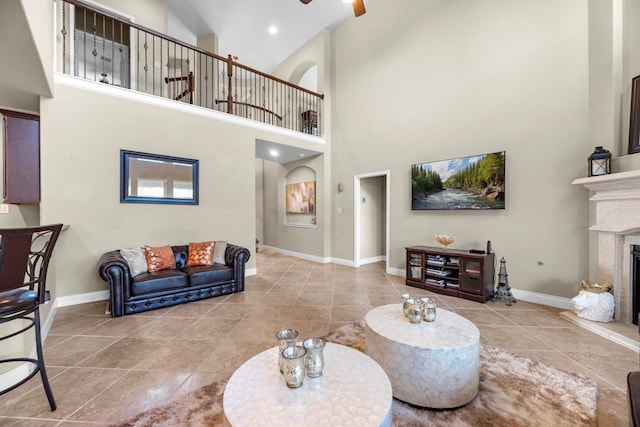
xmin=411 ymin=151 xmax=505 ymax=210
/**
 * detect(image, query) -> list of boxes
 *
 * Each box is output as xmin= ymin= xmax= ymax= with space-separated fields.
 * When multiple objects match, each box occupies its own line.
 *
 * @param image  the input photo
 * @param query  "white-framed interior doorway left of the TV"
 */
xmin=353 ymin=170 xmax=391 ymax=271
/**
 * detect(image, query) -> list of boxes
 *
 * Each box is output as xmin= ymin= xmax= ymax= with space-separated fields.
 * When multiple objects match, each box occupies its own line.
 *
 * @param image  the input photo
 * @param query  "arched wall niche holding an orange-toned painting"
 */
xmin=282 ymin=166 xmax=318 ymax=227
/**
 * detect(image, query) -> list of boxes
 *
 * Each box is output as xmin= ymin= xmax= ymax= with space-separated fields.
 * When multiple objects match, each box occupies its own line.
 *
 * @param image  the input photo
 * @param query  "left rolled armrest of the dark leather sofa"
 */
xmin=98 ymin=250 xmax=131 ymax=317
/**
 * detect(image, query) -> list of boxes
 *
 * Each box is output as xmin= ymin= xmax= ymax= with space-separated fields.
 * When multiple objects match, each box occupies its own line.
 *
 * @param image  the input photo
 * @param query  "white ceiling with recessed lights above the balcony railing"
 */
xmin=167 ymin=0 xmax=356 ymax=73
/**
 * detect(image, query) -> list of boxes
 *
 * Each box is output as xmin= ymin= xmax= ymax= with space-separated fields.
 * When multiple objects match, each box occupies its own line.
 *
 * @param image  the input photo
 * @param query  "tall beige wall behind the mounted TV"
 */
xmin=331 ymin=0 xmax=592 ymax=297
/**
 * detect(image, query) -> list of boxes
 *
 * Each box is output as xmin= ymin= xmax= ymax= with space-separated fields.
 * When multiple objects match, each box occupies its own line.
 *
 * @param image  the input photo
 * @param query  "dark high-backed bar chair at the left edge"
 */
xmin=0 ymin=224 xmax=62 ymax=411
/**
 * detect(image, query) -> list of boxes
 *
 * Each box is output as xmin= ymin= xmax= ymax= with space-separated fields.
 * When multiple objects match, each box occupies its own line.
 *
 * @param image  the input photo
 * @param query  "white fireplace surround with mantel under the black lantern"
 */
xmin=572 ymin=171 xmax=640 ymax=324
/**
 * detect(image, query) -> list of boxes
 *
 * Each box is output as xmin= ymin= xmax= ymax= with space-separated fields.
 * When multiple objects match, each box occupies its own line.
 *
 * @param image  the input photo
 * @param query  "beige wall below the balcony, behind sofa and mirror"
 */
xmin=41 ymin=77 xmax=324 ymax=296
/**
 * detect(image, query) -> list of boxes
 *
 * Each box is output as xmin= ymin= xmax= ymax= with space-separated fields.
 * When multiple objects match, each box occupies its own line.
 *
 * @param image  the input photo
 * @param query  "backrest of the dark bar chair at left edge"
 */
xmin=0 ymin=224 xmax=62 ymax=303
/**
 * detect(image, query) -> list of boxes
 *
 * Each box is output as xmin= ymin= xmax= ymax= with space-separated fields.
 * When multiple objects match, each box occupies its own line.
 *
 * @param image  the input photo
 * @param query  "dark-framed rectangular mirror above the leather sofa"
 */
xmin=120 ymin=150 xmax=198 ymax=205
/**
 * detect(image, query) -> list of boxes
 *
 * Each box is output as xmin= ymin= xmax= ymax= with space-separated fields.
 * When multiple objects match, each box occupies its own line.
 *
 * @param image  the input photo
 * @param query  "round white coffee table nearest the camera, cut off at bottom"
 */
xmin=222 ymin=343 xmax=393 ymax=427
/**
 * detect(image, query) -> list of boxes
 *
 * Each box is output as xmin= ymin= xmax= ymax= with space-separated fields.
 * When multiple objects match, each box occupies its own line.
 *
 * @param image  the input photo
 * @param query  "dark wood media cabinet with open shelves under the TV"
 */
xmin=406 ymin=246 xmax=495 ymax=302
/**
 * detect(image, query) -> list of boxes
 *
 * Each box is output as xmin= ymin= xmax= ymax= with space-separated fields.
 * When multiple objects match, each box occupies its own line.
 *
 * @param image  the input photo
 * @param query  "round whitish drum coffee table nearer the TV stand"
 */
xmin=365 ymin=304 xmax=480 ymax=408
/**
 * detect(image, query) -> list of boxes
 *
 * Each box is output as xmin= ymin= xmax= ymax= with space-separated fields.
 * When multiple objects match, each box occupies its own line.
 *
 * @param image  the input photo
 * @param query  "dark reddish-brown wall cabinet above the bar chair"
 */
xmin=0 ymin=110 xmax=40 ymax=204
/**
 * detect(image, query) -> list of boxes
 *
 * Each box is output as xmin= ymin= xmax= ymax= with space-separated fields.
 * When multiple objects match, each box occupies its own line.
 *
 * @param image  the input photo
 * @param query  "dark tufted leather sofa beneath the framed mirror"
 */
xmin=98 ymin=244 xmax=250 ymax=317
